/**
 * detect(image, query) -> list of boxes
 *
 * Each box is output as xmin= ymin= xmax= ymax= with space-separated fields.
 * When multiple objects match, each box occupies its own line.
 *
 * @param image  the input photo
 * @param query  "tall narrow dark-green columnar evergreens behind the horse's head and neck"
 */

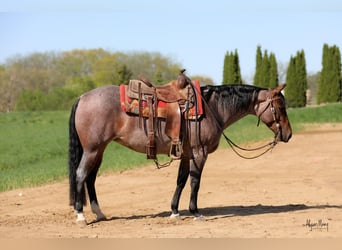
xmin=222 ymin=44 xmax=342 ymax=107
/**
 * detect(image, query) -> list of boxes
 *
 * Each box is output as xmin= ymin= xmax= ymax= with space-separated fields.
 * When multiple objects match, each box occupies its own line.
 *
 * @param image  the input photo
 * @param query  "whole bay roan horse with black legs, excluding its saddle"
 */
xmin=69 ymin=77 xmax=292 ymax=223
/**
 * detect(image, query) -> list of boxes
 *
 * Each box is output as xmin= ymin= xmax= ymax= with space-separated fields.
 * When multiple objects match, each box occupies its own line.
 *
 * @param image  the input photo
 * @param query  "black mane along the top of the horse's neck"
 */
xmin=202 ymin=84 xmax=263 ymax=108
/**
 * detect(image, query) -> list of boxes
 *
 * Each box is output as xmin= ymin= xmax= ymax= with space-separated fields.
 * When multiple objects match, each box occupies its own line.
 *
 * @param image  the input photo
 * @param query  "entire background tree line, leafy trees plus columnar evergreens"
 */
xmin=0 ymin=44 xmax=342 ymax=112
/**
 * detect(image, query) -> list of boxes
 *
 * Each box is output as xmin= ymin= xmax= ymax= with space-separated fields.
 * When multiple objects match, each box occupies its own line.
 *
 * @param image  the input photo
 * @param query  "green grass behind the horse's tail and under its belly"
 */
xmin=0 ymin=111 xmax=151 ymax=191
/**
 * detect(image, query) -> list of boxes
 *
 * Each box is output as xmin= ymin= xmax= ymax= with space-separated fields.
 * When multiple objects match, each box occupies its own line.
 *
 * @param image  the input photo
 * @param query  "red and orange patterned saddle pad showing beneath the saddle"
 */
xmin=120 ymin=80 xmax=203 ymax=120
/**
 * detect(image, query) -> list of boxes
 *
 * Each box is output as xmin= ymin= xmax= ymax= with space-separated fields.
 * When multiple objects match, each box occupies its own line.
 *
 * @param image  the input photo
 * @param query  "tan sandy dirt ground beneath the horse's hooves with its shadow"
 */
xmin=0 ymin=124 xmax=342 ymax=238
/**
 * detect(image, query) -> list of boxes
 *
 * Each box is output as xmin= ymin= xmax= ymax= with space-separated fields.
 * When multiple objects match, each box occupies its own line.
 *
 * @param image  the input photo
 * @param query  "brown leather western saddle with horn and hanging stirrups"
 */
xmin=128 ymin=69 xmax=195 ymax=160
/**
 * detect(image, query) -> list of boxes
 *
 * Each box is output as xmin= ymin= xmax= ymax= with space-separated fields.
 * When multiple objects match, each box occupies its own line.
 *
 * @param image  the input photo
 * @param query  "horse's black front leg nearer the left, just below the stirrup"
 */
xmin=171 ymin=158 xmax=190 ymax=218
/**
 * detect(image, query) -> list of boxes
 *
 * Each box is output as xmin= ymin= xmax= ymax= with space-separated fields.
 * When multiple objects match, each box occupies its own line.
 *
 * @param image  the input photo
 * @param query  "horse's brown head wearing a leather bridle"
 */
xmin=254 ymin=84 xmax=292 ymax=142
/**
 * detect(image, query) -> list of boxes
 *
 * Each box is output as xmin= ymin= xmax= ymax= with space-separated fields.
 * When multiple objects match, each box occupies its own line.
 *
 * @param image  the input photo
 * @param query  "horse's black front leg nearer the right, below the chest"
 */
xmin=189 ymin=149 xmax=207 ymax=219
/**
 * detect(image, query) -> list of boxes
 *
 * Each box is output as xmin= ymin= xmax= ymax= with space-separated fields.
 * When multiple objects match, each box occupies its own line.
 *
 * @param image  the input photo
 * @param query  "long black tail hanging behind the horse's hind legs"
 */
xmin=69 ymin=98 xmax=86 ymax=206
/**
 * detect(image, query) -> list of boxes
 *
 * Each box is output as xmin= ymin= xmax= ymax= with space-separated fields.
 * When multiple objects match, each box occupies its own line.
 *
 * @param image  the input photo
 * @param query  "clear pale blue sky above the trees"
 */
xmin=0 ymin=0 xmax=342 ymax=84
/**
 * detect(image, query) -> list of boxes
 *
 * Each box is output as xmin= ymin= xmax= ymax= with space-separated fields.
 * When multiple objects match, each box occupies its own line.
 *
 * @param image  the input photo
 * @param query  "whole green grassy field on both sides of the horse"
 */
xmin=0 ymin=103 xmax=342 ymax=192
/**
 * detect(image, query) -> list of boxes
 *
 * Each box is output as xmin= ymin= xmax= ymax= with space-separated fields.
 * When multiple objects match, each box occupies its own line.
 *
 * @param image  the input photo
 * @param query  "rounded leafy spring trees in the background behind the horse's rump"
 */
xmin=0 ymin=49 xmax=208 ymax=112
